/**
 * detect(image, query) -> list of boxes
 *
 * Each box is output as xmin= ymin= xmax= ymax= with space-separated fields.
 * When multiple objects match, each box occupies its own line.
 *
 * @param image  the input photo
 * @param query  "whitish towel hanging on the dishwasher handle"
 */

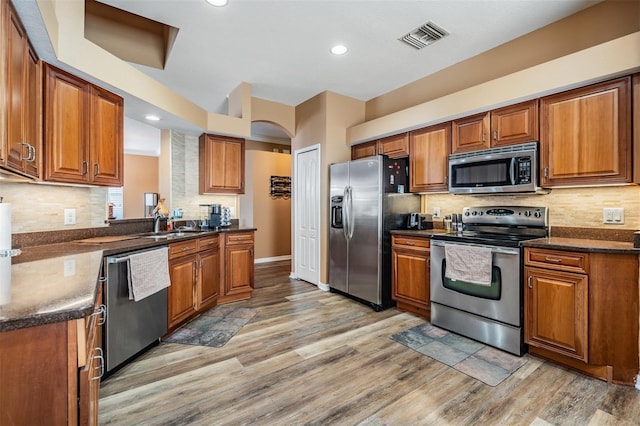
xmin=127 ymin=247 xmax=171 ymax=302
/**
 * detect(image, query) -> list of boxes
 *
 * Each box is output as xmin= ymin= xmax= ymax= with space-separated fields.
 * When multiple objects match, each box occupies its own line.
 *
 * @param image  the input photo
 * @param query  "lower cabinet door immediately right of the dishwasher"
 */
xmin=168 ymin=255 xmax=198 ymax=329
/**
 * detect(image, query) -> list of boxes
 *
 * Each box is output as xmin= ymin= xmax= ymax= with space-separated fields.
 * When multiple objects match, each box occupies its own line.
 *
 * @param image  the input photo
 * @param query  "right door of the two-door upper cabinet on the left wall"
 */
xmin=89 ymin=86 xmax=124 ymax=186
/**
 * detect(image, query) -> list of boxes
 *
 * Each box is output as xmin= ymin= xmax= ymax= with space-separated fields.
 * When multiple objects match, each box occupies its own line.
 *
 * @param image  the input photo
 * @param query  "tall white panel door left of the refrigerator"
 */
xmin=293 ymin=145 xmax=320 ymax=285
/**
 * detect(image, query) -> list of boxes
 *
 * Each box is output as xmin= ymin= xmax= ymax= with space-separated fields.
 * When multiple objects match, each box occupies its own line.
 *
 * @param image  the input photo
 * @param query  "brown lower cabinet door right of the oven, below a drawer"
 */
xmin=524 ymin=268 xmax=589 ymax=362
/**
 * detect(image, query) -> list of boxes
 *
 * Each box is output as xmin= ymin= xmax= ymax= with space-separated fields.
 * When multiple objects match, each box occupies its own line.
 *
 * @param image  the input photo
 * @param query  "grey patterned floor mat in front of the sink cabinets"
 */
xmin=164 ymin=305 xmax=256 ymax=348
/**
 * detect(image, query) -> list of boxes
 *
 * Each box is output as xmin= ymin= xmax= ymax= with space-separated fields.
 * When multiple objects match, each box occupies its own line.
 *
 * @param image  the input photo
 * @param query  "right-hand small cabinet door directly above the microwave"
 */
xmin=491 ymin=99 xmax=539 ymax=147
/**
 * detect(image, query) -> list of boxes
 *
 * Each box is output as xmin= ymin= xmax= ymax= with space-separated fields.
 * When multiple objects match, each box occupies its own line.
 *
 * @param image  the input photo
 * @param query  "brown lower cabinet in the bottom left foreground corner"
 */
xmin=0 ymin=282 xmax=104 ymax=425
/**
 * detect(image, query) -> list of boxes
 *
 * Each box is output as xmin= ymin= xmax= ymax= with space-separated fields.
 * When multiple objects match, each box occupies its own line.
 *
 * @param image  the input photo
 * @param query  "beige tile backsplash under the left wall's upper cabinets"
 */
xmin=0 ymin=182 xmax=107 ymax=234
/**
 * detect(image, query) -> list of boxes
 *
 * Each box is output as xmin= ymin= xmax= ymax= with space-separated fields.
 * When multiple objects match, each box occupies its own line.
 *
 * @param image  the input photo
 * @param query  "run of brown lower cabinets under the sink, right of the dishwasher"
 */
xmin=167 ymin=231 xmax=254 ymax=331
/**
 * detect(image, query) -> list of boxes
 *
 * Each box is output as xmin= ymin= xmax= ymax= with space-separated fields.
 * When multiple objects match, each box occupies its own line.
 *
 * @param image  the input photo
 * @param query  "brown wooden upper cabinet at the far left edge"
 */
xmin=0 ymin=1 xmax=42 ymax=178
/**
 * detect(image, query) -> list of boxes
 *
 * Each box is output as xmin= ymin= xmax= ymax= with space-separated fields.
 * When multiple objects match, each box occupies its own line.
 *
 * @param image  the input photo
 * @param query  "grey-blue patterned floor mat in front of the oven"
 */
xmin=391 ymin=323 xmax=527 ymax=386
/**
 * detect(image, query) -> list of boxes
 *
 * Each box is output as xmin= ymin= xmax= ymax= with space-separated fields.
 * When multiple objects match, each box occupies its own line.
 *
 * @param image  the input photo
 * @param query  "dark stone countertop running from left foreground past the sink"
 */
xmin=0 ymin=226 xmax=255 ymax=332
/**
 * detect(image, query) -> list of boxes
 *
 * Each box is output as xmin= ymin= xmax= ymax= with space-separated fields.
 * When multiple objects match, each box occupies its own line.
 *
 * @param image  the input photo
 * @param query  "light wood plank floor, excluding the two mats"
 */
xmin=100 ymin=262 xmax=640 ymax=425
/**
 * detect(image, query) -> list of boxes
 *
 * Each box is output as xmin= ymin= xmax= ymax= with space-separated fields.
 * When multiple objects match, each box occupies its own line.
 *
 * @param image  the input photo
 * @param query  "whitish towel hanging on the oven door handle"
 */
xmin=444 ymin=244 xmax=493 ymax=286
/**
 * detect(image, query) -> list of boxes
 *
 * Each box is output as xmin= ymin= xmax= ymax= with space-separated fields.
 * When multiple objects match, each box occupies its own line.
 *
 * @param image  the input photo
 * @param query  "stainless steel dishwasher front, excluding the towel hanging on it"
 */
xmin=103 ymin=247 xmax=167 ymax=375
